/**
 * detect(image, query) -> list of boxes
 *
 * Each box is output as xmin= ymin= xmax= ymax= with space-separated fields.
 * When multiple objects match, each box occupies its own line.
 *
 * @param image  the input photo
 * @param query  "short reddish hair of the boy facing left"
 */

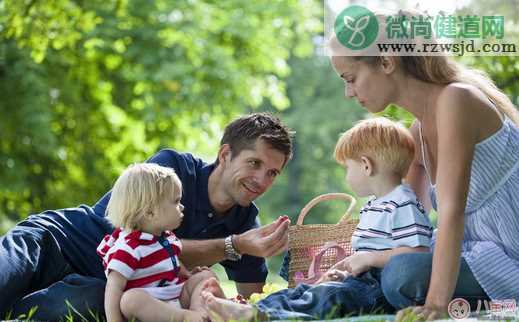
xmin=335 ymin=117 xmax=415 ymax=177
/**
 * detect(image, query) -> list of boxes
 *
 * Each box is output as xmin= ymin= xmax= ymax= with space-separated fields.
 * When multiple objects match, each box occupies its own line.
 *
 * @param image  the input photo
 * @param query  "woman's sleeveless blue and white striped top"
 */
xmin=430 ymin=118 xmax=519 ymax=301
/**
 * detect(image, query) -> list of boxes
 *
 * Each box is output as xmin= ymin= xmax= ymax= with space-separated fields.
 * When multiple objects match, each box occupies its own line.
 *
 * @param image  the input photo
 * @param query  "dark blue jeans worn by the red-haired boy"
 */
xmin=256 ymin=269 xmax=393 ymax=320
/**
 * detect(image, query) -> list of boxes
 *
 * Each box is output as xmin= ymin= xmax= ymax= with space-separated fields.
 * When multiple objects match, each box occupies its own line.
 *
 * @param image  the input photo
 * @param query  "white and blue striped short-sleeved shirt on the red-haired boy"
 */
xmin=351 ymin=184 xmax=432 ymax=251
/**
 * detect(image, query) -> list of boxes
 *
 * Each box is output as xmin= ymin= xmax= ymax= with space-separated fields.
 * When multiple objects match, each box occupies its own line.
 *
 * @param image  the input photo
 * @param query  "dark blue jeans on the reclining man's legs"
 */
xmin=0 ymin=220 xmax=106 ymax=321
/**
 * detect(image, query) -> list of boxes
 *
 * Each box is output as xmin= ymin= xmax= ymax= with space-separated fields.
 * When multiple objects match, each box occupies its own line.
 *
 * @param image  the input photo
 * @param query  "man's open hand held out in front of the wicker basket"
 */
xmin=233 ymin=216 xmax=290 ymax=257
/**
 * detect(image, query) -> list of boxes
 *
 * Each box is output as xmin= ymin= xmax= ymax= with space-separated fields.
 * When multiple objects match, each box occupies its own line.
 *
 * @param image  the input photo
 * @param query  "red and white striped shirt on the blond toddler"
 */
xmin=97 ymin=228 xmax=185 ymax=299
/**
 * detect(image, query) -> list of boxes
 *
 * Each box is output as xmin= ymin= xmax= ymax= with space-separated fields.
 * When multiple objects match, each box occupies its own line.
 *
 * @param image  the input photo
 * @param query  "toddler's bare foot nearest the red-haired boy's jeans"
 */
xmin=202 ymin=292 xmax=255 ymax=322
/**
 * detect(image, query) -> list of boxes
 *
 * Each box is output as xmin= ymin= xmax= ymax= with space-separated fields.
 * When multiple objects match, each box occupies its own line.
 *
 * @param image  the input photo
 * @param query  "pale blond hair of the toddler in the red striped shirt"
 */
xmin=106 ymin=163 xmax=182 ymax=230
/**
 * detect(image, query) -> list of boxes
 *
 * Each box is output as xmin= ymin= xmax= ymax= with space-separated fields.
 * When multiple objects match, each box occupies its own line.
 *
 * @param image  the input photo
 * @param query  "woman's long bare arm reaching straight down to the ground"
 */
xmin=422 ymin=86 xmax=479 ymax=318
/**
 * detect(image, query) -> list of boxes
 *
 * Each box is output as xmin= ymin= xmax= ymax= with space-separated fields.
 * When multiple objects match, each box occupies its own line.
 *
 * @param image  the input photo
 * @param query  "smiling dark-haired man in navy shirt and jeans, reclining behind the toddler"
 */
xmin=0 ymin=113 xmax=292 ymax=320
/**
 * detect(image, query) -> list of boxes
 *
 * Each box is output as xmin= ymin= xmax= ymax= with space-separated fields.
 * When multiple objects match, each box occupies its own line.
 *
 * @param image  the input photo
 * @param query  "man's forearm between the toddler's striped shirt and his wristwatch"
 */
xmin=180 ymin=239 xmax=225 ymax=270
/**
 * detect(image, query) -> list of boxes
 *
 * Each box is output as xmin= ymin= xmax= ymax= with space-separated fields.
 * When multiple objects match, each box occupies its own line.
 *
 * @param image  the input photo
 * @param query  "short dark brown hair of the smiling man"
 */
xmin=216 ymin=113 xmax=295 ymax=166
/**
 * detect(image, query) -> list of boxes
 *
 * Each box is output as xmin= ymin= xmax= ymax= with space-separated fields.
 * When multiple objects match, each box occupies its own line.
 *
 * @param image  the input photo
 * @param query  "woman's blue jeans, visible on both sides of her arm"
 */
xmin=381 ymin=253 xmax=489 ymax=309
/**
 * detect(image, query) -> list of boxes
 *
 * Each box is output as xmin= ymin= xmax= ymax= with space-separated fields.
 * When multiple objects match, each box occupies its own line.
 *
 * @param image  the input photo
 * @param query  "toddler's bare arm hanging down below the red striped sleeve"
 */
xmin=105 ymin=270 xmax=127 ymax=322
